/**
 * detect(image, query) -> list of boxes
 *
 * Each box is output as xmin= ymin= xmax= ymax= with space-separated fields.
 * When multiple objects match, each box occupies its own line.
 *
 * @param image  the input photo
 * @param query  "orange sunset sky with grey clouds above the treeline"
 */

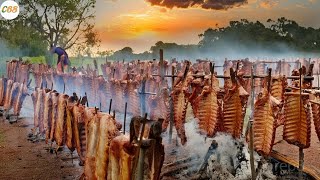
xmin=95 ymin=0 xmax=320 ymax=53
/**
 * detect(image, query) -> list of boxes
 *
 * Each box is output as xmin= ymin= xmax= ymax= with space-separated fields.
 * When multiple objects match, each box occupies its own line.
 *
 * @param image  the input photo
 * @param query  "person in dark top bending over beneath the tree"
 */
xmin=50 ymin=45 xmax=70 ymax=73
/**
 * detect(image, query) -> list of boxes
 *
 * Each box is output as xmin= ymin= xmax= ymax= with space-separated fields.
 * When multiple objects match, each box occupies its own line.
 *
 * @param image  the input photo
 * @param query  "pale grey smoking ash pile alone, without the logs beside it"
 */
xmin=193 ymin=134 xmax=277 ymax=180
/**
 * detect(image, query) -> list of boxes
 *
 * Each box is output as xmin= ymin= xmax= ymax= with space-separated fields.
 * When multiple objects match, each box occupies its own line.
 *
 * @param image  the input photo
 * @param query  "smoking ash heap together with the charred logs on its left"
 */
xmin=162 ymin=133 xmax=277 ymax=180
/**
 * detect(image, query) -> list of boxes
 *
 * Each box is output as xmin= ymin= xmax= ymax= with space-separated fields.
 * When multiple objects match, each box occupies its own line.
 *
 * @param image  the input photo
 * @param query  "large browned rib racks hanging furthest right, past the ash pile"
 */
xmin=253 ymin=66 xmax=320 ymax=156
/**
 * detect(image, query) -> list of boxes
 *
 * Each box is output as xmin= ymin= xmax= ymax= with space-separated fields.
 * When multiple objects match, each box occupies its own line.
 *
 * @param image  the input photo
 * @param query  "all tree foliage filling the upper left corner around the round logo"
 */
xmin=0 ymin=0 xmax=99 ymax=55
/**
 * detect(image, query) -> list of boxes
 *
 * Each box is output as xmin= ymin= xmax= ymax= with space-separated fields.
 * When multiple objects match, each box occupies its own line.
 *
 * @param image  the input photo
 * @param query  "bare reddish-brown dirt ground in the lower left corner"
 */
xmin=0 ymin=102 xmax=83 ymax=179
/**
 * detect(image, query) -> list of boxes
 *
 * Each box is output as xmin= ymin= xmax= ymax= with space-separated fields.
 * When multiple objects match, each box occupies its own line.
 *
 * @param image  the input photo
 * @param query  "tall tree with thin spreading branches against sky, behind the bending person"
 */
xmin=20 ymin=0 xmax=99 ymax=49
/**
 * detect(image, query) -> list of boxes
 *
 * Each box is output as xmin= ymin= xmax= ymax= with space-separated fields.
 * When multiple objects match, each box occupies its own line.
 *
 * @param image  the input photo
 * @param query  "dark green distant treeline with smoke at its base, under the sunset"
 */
xmin=108 ymin=17 xmax=320 ymax=60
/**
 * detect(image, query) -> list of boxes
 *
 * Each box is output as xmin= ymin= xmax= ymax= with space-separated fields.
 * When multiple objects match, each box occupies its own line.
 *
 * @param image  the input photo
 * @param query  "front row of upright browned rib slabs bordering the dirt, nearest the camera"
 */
xmin=31 ymin=88 xmax=164 ymax=180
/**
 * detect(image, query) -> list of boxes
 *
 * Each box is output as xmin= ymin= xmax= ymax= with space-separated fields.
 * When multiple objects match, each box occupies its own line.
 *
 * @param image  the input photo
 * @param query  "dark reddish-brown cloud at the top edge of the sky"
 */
xmin=146 ymin=0 xmax=248 ymax=10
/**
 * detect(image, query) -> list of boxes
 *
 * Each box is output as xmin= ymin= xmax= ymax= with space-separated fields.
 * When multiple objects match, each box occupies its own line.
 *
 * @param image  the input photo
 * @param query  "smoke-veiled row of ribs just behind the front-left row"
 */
xmin=34 ymin=62 xmax=167 ymax=115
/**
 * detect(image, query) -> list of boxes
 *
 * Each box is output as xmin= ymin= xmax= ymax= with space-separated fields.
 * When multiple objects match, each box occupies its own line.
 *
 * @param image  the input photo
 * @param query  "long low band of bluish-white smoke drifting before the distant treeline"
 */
xmin=108 ymin=38 xmax=320 ymax=65
